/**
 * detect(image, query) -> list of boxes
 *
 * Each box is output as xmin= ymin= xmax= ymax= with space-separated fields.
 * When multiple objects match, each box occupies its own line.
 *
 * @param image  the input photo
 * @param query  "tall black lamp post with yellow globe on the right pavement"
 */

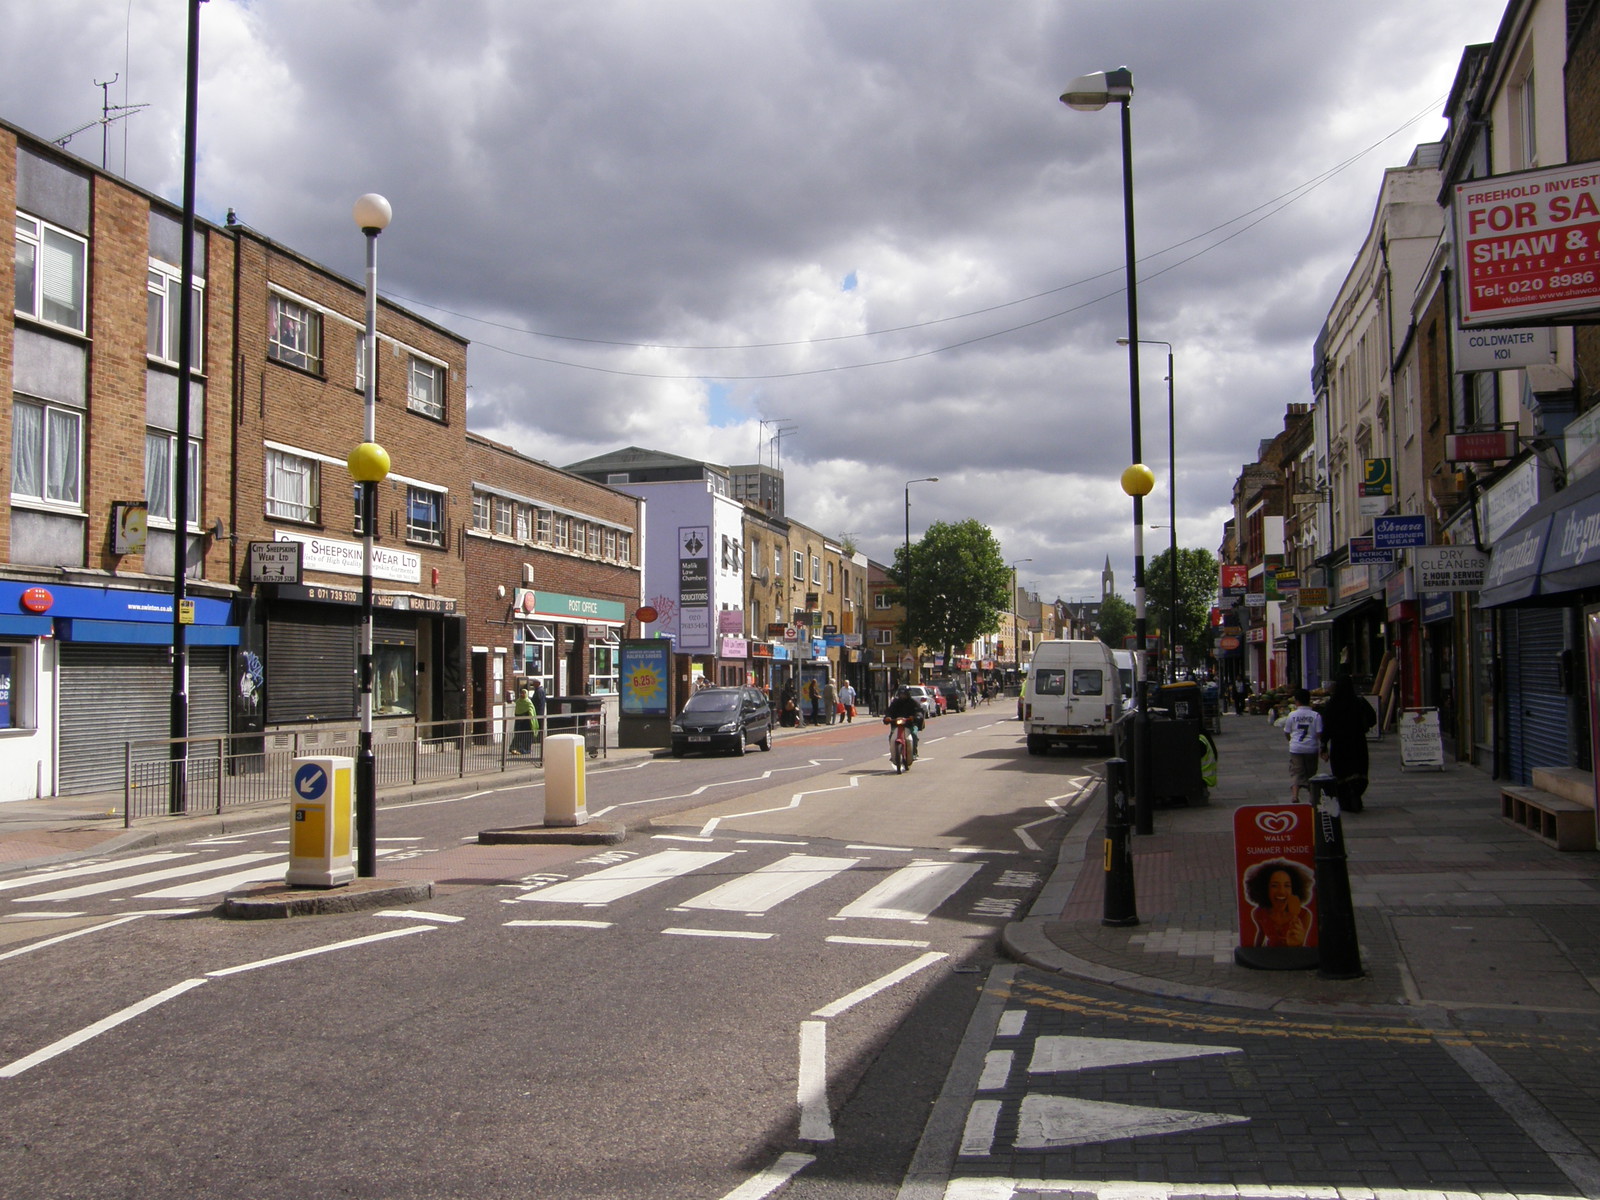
xmin=1061 ymin=67 xmax=1155 ymax=834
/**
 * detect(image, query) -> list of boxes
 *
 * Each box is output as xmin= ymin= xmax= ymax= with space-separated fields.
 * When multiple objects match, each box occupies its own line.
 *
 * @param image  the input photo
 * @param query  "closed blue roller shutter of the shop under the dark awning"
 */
xmin=1506 ymin=608 xmax=1576 ymax=784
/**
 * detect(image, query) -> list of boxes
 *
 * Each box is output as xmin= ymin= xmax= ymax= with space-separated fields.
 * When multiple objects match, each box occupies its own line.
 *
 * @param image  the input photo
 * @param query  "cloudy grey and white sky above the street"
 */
xmin=0 ymin=0 xmax=1504 ymax=611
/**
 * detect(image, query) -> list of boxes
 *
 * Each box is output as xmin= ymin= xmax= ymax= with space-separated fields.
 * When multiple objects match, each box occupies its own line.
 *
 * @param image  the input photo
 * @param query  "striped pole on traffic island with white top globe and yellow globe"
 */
xmin=346 ymin=192 xmax=394 ymax=878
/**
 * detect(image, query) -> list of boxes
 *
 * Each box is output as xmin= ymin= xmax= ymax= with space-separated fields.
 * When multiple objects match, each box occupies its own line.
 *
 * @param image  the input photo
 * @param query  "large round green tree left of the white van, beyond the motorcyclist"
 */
xmin=890 ymin=518 xmax=1013 ymax=662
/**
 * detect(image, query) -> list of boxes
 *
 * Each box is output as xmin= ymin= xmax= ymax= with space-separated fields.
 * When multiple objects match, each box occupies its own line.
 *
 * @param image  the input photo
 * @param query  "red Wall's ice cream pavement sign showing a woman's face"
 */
xmin=1234 ymin=805 xmax=1317 ymax=949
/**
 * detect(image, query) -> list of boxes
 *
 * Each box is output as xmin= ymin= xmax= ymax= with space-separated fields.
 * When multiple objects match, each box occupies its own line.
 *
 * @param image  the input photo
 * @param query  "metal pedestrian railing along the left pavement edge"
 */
xmin=122 ymin=710 xmax=606 ymax=827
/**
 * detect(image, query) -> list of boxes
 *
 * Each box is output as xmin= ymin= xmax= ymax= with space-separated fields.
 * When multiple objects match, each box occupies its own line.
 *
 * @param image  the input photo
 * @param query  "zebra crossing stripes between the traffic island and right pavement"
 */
xmin=492 ymin=843 xmax=1004 ymax=944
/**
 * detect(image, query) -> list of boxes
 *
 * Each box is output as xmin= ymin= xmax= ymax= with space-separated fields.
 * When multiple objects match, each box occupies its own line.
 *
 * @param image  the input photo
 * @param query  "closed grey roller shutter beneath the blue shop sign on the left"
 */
xmin=56 ymin=642 xmax=229 ymax=795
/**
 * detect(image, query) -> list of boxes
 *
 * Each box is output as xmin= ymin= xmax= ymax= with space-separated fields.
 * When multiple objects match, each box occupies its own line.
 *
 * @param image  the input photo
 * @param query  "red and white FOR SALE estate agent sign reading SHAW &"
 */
xmin=1453 ymin=162 xmax=1600 ymax=328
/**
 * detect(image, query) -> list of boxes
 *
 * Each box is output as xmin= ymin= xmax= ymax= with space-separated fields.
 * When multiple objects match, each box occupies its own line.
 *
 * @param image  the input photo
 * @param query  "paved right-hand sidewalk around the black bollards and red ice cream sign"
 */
xmin=1005 ymin=715 xmax=1600 ymax=1026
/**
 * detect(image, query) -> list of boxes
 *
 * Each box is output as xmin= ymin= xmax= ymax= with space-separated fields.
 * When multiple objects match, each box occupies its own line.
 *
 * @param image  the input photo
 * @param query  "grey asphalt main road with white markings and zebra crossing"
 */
xmin=0 ymin=707 xmax=1088 ymax=1200
